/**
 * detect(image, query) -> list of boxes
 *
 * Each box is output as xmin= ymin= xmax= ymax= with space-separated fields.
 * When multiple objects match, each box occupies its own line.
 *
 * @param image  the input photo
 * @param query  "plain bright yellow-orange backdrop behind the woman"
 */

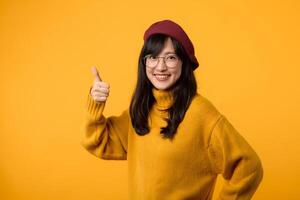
xmin=0 ymin=0 xmax=300 ymax=200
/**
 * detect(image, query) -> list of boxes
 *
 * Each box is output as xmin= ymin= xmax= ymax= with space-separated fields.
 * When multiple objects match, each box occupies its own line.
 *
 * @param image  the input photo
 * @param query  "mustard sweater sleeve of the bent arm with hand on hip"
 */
xmin=208 ymin=115 xmax=263 ymax=200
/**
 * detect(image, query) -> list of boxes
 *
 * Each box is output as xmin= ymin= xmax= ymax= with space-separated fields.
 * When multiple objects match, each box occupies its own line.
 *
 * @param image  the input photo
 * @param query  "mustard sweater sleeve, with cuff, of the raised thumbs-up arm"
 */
xmin=81 ymin=91 xmax=129 ymax=160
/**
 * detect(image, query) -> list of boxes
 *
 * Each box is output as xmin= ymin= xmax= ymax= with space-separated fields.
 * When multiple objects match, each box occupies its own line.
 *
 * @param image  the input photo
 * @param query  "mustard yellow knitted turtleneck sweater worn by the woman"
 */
xmin=81 ymin=88 xmax=263 ymax=200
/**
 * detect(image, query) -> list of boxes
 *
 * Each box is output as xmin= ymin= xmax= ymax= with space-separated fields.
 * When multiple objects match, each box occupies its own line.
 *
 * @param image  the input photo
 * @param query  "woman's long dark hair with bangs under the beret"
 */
xmin=130 ymin=34 xmax=197 ymax=139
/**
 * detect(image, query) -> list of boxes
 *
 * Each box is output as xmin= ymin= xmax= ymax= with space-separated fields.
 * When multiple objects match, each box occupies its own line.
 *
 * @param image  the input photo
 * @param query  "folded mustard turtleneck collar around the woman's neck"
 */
xmin=152 ymin=87 xmax=173 ymax=110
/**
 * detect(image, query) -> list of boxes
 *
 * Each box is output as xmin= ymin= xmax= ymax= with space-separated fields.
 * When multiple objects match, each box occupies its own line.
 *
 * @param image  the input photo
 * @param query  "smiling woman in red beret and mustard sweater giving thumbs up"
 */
xmin=82 ymin=20 xmax=263 ymax=200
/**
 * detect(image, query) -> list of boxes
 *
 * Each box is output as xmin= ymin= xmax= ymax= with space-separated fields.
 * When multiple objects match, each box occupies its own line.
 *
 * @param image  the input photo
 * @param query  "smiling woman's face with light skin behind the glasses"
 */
xmin=146 ymin=38 xmax=182 ymax=90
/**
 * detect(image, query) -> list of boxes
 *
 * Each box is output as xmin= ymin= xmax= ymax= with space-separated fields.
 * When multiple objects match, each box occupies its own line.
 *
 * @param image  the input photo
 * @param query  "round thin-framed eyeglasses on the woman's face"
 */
xmin=144 ymin=54 xmax=180 ymax=68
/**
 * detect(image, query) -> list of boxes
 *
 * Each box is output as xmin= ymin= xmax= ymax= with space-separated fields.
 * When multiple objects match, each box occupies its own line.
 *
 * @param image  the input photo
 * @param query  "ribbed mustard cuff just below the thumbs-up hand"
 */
xmin=86 ymin=93 xmax=106 ymax=119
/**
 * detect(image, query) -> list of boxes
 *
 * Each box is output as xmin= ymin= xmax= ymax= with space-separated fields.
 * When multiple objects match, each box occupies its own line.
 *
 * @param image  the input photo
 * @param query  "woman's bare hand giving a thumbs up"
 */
xmin=90 ymin=67 xmax=109 ymax=102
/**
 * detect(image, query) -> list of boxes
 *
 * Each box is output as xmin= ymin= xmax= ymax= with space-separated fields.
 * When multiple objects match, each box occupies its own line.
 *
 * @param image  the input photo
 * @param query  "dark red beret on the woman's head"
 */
xmin=144 ymin=20 xmax=199 ymax=70
